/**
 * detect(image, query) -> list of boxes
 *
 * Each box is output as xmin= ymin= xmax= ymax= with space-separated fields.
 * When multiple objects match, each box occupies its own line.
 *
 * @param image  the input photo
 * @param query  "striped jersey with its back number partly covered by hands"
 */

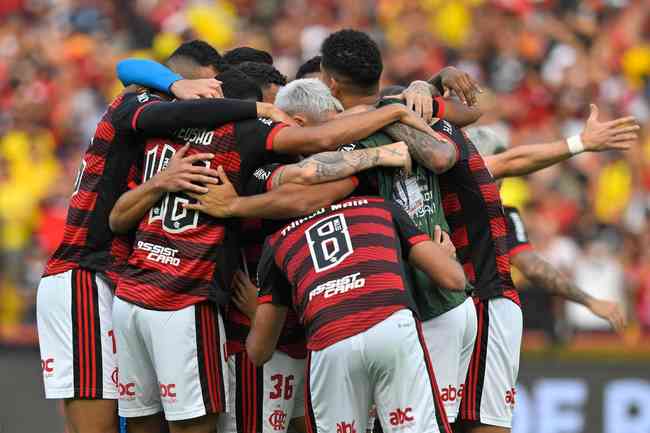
xmin=116 ymin=119 xmax=286 ymax=310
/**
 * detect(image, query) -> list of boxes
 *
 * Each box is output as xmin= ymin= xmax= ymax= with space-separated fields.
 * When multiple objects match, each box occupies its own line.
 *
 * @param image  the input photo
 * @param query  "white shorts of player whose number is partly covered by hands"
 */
xmin=113 ymin=298 xmax=228 ymax=421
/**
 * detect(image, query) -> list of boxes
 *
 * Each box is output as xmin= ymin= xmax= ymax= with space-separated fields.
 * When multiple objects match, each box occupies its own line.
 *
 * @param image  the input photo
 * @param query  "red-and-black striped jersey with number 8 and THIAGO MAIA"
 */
xmin=258 ymin=197 xmax=430 ymax=350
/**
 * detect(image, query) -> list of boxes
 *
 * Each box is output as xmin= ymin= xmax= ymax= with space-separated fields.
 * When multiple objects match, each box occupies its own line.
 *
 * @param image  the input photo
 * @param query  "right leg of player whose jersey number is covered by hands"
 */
xmin=153 ymin=302 xmax=228 ymax=433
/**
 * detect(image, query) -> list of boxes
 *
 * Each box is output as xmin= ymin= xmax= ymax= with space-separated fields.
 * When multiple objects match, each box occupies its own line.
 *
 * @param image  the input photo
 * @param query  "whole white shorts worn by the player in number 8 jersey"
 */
xmin=305 ymin=310 xmax=451 ymax=433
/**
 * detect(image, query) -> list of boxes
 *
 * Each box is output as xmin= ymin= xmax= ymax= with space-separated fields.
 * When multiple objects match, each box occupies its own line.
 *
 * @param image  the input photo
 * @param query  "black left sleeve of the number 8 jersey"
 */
xmin=257 ymin=239 xmax=291 ymax=307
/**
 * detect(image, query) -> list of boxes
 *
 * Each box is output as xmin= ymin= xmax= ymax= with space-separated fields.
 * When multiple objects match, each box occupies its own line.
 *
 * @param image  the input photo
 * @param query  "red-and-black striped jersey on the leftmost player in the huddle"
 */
xmin=44 ymin=93 xmax=159 ymax=282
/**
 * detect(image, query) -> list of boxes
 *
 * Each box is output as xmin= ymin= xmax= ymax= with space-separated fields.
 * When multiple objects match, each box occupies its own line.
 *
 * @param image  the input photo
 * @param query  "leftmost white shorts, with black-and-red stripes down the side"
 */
xmin=36 ymin=269 xmax=118 ymax=399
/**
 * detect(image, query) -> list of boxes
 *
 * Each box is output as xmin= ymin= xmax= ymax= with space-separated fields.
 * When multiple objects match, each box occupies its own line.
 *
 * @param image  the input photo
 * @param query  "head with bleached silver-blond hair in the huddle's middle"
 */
xmin=275 ymin=78 xmax=343 ymax=126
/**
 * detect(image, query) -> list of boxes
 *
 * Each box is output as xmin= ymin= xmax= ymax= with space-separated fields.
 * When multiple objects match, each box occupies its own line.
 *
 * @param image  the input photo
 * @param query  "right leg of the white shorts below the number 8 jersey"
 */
xmin=364 ymin=310 xmax=451 ymax=433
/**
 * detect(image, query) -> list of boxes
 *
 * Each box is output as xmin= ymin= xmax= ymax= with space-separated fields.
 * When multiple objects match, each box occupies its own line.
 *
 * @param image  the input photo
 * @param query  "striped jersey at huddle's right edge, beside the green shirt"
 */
xmin=433 ymin=120 xmax=519 ymax=302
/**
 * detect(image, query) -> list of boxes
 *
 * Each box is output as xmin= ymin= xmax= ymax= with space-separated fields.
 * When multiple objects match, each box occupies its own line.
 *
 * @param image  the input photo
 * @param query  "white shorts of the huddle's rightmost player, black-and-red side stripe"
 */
xmin=460 ymin=298 xmax=523 ymax=428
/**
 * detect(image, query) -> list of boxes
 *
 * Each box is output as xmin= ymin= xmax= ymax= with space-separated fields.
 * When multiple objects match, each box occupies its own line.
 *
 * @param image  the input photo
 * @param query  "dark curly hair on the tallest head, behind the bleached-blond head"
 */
xmin=321 ymin=29 xmax=383 ymax=92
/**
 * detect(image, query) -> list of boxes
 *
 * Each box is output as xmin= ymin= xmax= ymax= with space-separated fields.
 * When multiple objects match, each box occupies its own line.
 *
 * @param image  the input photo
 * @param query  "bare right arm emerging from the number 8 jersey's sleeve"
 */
xmin=409 ymin=241 xmax=466 ymax=291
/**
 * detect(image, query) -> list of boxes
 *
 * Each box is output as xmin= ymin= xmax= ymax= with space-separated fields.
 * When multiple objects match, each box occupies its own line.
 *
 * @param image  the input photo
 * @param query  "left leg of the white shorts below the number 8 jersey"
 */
xmin=305 ymin=334 xmax=372 ymax=433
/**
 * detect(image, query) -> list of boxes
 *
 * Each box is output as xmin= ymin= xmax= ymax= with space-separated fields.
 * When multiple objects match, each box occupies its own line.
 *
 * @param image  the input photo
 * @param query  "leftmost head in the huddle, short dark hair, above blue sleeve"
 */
xmin=165 ymin=40 xmax=223 ymax=79
